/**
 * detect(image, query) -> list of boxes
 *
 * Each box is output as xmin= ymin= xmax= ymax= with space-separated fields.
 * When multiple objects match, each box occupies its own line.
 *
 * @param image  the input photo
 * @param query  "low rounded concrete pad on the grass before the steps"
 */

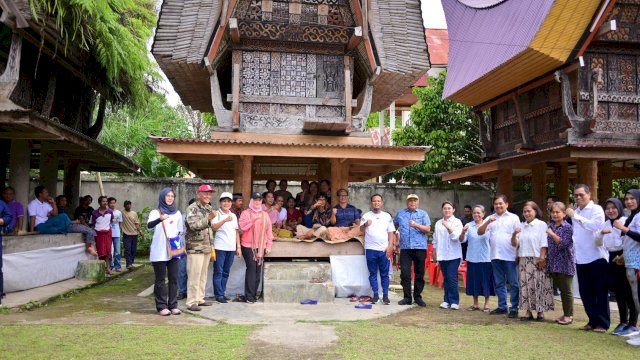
xmin=180 ymin=293 xmax=416 ymax=324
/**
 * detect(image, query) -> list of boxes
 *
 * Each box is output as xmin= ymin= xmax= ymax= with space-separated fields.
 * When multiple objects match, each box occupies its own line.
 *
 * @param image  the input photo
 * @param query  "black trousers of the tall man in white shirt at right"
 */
xmin=576 ymin=259 xmax=611 ymax=329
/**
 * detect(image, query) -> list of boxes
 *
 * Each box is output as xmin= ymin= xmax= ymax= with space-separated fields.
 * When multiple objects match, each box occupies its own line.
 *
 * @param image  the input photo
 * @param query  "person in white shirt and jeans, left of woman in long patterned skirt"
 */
xmin=478 ymin=195 xmax=520 ymax=319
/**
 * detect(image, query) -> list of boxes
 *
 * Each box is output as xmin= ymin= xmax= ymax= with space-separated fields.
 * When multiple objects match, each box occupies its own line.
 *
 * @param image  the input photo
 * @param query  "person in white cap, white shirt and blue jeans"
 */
xmin=211 ymin=192 xmax=242 ymax=304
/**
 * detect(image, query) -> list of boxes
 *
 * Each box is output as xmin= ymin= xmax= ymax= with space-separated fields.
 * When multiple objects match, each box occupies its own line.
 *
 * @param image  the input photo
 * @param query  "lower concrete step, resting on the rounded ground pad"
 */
xmin=264 ymin=280 xmax=336 ymax=306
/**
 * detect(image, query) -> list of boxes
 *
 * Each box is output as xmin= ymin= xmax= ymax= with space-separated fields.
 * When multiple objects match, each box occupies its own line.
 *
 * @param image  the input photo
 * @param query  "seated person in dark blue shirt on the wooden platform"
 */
xmin=327 ymin=189 xmax=363 ymax=242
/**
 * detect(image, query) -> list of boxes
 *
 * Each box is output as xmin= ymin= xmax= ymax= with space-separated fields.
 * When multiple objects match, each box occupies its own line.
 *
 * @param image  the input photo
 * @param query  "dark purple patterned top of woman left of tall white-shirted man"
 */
xmin=547 ymin=221 xmax=576 ymax=275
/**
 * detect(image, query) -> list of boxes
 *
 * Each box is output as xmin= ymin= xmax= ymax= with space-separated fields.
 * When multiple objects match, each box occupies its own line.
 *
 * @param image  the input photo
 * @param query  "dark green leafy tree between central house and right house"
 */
xmin=392 ymin=72 xmax=482 ymax=185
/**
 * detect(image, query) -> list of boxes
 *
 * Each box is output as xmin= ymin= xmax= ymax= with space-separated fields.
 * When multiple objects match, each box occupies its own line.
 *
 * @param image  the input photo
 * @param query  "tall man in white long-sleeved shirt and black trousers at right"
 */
xmin=567 ymin=184 xmax=611 ymax=333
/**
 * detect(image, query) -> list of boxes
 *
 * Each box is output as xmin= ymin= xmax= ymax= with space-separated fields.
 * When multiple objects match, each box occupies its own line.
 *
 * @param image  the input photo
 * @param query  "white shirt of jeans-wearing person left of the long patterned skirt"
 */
xmin=485 ymin=211 xmax=520 ymax=261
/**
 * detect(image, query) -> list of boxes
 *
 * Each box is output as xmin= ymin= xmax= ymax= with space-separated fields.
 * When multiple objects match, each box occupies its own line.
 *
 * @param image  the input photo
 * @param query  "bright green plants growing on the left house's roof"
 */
xmin=30 ymin=0 xmax=159 ymax=107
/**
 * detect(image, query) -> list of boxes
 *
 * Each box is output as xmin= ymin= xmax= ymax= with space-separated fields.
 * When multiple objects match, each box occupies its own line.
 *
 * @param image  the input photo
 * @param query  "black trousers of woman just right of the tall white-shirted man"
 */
xmin=608 ymin=250 xmax=638 ymax=326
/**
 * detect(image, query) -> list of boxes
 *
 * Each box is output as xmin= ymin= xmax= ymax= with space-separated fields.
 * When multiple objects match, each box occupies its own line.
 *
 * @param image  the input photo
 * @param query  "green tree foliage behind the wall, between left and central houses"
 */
xmin=99 ymin=93 xmax=192 ymax=177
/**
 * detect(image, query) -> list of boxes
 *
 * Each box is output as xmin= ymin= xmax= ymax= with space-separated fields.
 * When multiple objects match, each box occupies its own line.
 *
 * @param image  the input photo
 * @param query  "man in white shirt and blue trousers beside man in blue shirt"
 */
xmin=360 ymin=194 xmax=396 ymax=305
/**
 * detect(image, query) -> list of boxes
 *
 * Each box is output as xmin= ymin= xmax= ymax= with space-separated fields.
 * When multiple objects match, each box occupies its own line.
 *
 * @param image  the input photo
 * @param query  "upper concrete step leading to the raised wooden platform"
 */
xmin=264 ymin=262 xmax=331 ymax=282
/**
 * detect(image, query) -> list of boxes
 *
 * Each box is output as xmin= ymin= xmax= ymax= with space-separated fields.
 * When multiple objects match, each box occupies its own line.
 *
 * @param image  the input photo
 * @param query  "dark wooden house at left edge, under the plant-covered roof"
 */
xmin=0 ymin=0 xmax=138 ymax=221
